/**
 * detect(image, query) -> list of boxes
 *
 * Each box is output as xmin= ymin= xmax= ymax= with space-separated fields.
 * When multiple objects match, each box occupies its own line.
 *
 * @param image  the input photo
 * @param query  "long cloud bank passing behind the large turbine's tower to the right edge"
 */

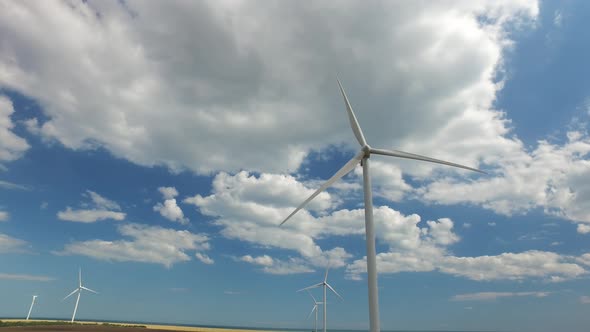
xmin=185 ymin=172 xmax=586 ymax=281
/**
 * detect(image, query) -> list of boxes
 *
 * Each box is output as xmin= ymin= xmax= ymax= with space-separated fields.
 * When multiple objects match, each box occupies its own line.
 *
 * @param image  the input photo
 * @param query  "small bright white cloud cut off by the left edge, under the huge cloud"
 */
xmin=0 ymin=95 xmax=30 ymax=164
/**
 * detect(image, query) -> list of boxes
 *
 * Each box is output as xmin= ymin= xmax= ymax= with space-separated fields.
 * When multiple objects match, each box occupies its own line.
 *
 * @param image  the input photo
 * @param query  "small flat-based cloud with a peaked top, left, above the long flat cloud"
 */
xmin=57 ymin=190 xmax=126 ymax=223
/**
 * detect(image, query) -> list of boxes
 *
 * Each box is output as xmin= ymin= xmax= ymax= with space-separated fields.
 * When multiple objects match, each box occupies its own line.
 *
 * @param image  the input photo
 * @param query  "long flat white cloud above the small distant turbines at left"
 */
xmin=54 ymin=224 xmax=213 ymax=268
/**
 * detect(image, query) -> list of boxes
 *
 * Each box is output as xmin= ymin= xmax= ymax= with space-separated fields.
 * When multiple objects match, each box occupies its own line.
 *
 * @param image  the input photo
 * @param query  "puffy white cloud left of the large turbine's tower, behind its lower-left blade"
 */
xmin=184 ymin=172 xmax=354 ymax=273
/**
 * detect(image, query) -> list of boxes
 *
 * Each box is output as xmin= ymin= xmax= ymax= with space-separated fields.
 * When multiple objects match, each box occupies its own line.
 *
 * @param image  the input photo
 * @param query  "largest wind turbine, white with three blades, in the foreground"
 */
xmin=281 ymin=80 xmax=485 ymax=332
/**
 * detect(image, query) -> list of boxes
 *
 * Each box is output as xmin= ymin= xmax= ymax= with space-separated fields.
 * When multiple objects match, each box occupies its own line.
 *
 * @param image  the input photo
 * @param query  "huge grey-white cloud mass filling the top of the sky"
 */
xmin=0 ymin=0 xmax=539 ymax=179
